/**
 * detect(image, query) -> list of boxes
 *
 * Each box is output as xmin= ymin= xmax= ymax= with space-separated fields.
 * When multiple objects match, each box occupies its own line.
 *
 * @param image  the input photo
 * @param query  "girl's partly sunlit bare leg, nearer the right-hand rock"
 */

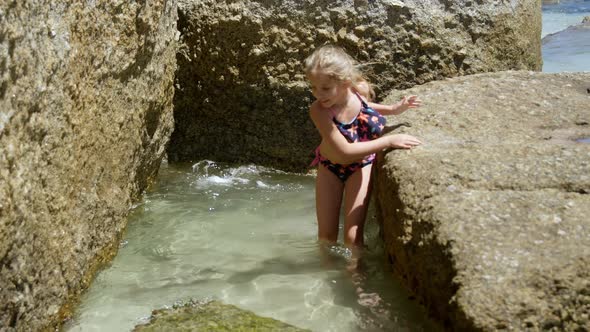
xmin=344 ymin=164 xmax=373 ymax=247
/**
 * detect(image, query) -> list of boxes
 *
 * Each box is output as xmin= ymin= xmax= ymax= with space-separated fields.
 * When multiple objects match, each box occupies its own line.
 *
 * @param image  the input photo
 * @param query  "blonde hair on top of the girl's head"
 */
xmin=304 ymin=45 xmax=362 ymax=85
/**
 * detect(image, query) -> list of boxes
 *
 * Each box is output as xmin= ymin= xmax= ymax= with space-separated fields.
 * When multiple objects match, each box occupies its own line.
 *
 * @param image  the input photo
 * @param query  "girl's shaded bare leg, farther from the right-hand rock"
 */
xmin=315 ymin=165 xmax=344 ymax=243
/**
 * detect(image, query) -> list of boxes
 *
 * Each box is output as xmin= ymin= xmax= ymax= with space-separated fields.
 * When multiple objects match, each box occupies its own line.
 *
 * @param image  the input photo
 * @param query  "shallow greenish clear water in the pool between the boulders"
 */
xmin=64 ymin=161 xmax=434 ymax=331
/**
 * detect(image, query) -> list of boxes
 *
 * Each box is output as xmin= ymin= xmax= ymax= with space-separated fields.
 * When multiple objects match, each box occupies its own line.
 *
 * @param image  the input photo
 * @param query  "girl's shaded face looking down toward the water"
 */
xmin=307 ymin=71 xmax=350 ymax=108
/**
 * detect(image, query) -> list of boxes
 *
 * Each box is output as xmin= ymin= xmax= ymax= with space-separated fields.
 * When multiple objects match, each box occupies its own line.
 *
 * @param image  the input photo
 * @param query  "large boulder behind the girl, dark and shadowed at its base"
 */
xmin=168 ymin=0 xmax=541 ymax=170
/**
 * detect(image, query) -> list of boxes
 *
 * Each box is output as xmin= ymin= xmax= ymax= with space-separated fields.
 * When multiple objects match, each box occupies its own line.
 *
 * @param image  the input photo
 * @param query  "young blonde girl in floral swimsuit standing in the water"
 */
xmin=305 ymin=45 xmax=421 ymax=247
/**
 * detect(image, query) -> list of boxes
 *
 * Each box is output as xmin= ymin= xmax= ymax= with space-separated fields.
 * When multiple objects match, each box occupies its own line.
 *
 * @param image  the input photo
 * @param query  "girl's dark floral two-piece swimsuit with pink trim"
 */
xmin=311 ymin=93 xmax=385 ymax=182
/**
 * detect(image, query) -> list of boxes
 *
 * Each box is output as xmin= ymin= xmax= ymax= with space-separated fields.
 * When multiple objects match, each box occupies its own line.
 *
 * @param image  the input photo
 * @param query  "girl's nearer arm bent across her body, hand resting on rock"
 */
xmin=309 ymin=103 xmax=421 ymax=164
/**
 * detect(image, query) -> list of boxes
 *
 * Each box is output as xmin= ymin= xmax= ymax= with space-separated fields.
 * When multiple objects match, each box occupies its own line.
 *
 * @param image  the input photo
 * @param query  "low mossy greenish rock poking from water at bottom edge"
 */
xmin=133 ymin=301 xmax=309 ymax=332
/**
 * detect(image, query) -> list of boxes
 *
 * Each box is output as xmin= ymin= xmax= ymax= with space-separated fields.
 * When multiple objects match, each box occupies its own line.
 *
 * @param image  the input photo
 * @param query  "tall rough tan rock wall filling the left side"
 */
xmin=0 ymin=0 xmax=177 ymax=331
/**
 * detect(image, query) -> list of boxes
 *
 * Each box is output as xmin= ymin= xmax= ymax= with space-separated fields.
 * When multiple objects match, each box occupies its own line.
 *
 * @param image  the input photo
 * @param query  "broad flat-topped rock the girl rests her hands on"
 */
xmin=375 ymin=72 xmax=590 ymax=331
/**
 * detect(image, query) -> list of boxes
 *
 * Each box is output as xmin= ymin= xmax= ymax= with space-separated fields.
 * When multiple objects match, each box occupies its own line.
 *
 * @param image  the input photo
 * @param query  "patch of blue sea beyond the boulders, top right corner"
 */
xmin=542 ymin=0 xmax=590 ymax=72
